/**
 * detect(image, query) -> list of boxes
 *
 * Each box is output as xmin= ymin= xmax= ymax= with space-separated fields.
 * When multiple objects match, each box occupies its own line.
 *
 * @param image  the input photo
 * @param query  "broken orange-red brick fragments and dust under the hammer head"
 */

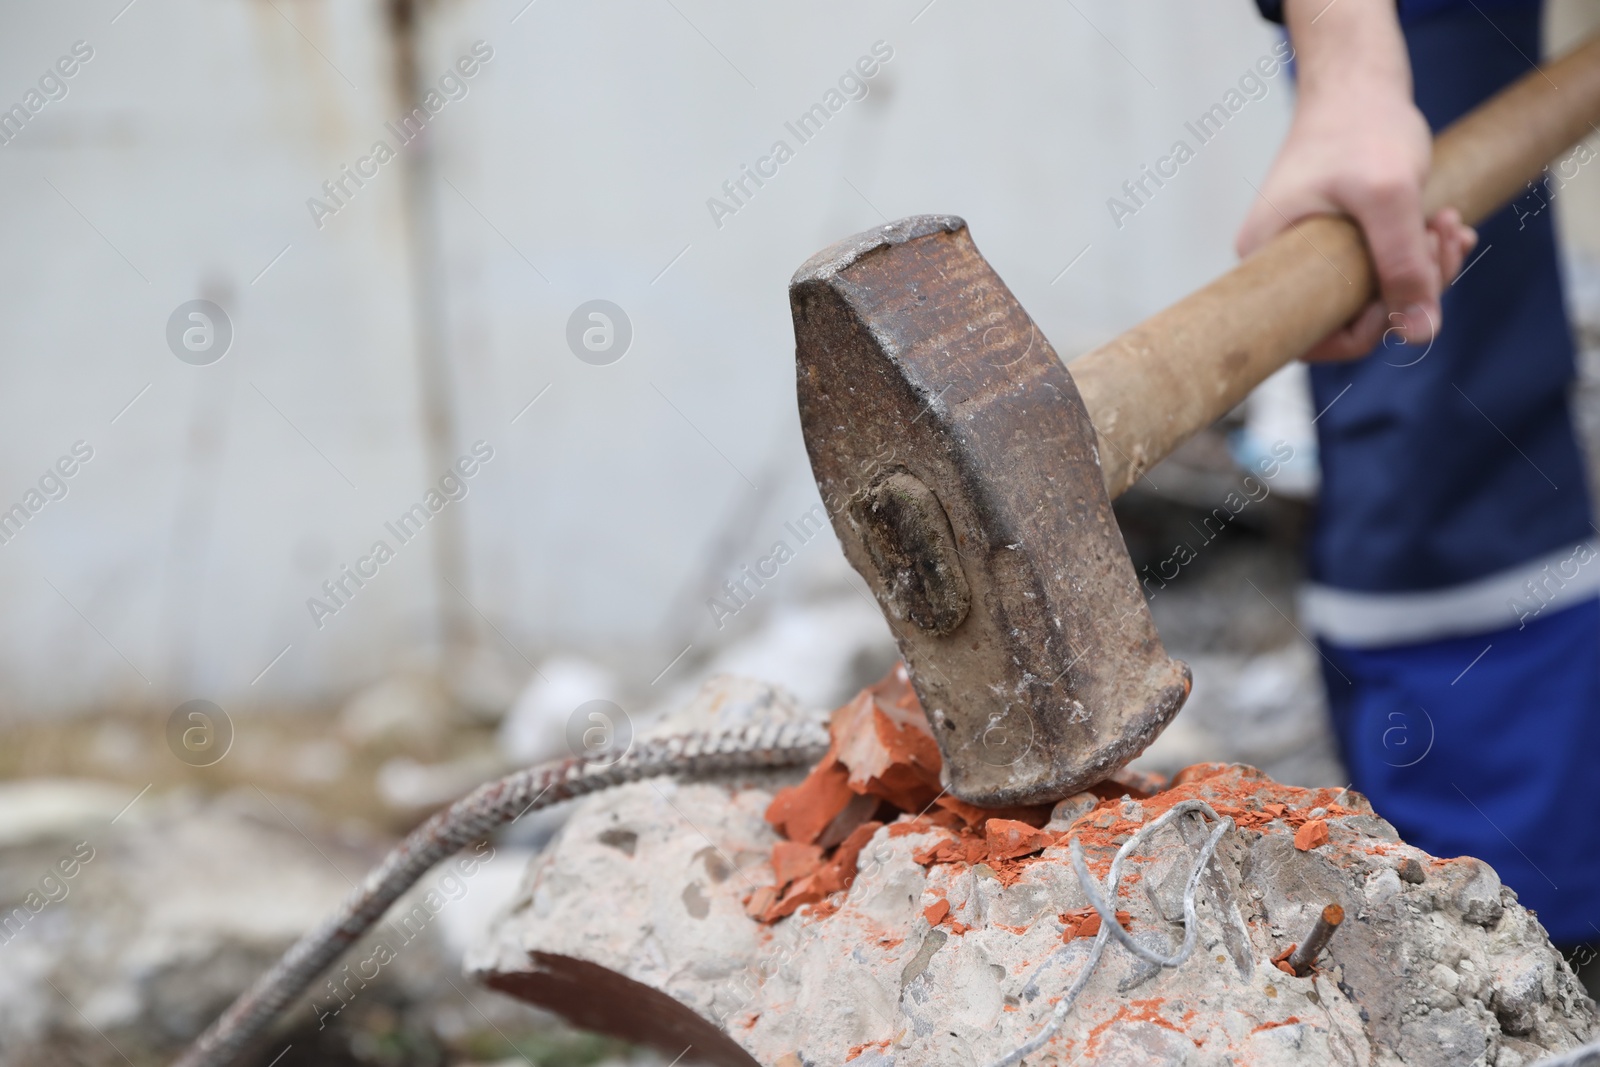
xmin=746 ymin=664 xmax=1360 ymax=927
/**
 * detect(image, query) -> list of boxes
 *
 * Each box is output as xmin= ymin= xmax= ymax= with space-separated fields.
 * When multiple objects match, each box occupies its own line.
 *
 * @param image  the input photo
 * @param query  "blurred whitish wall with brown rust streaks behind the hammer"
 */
xmin=0 ymin=0 xmax=1290 ymax=713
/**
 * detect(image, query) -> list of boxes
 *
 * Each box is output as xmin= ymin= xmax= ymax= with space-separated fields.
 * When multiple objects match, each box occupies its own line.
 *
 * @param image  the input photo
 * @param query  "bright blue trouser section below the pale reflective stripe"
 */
xmin=1322 ymin=601 xmax=1600 ymax=944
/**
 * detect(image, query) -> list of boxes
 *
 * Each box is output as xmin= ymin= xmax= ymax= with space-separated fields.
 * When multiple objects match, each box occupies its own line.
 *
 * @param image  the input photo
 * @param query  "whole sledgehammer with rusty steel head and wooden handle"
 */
xmin=789 ymin=29 xmax=1600 ymax=806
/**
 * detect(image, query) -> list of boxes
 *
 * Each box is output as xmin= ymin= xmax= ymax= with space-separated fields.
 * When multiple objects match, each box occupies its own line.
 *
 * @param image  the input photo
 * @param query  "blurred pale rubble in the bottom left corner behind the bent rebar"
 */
xmin=0 ymin=779 xmax=531 ymax=1067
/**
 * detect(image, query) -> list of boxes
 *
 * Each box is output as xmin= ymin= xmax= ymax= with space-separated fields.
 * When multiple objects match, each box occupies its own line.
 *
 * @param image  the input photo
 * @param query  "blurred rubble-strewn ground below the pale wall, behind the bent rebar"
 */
xmin=0 ymin=686 xmax=681 ymax=1067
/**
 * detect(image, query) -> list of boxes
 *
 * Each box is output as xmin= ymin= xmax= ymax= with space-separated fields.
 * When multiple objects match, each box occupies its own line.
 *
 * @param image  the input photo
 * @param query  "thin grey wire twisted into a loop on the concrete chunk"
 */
xmin=990 ymin=800 xmax=1234 ymax=1067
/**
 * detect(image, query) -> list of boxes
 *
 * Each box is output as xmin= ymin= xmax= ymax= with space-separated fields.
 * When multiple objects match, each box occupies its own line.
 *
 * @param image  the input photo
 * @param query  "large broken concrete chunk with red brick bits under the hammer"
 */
xmin=467 ymin=670 xmax=1597 ymax=1067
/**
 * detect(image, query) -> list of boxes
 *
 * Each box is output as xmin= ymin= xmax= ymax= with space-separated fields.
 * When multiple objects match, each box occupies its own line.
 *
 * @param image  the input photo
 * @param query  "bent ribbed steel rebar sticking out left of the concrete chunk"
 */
xmin=176 ymin=721 xmax=829 ymax=1067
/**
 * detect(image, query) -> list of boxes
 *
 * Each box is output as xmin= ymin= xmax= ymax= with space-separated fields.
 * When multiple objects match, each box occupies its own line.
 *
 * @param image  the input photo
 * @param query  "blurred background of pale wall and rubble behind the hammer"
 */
xmin=9 ymin=0 xmax=1600 ymax=1065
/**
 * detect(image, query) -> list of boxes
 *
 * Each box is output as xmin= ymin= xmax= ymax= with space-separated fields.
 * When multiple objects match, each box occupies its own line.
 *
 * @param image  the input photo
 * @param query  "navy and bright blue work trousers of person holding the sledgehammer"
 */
xmin=1309 ymin=6 xmax=1600 ymax=942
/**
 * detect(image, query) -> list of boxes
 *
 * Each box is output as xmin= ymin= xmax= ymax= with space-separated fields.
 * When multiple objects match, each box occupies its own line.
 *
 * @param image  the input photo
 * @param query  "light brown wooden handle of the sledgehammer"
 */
xmin=1069 ymin=37 xmax=1600 ymax=498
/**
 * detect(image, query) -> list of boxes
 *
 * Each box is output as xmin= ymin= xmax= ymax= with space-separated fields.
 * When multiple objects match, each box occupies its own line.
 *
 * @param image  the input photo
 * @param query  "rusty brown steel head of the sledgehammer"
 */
xmin=789 ymin=216 xmax=1189 ymax=806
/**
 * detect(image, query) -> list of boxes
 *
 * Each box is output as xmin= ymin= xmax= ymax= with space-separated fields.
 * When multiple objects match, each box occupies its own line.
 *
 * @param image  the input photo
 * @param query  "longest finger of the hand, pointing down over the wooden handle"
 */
xmin=1349 ymin=181 xmax=1440 ymax=342
